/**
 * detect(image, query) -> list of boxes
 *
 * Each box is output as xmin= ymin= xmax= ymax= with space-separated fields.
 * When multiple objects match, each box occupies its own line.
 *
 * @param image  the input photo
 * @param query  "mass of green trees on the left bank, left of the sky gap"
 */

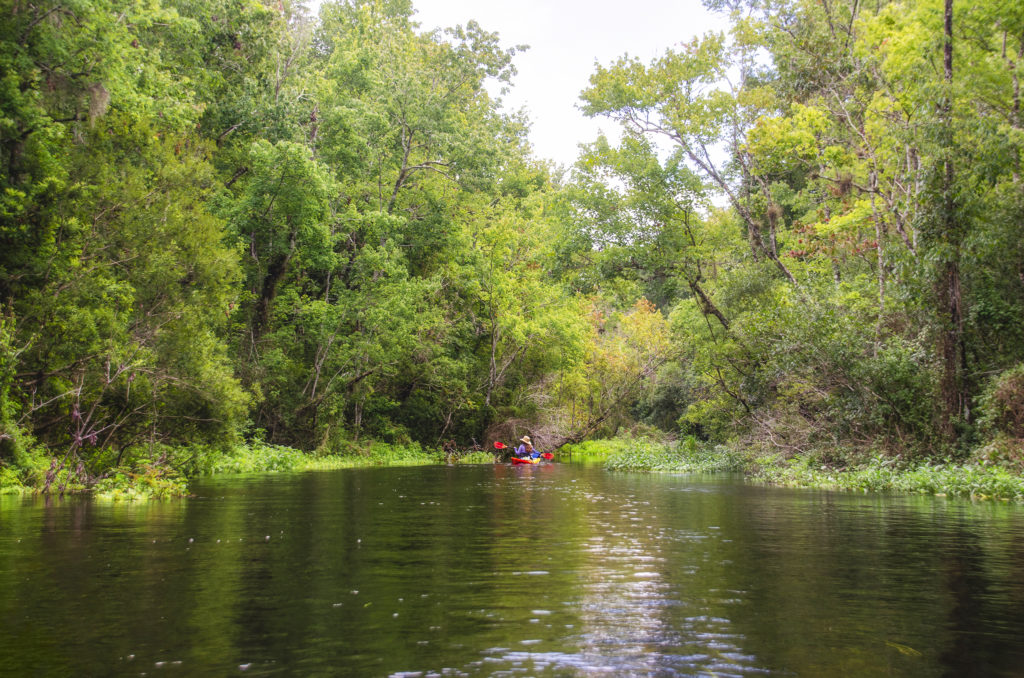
xmin=0 ymin=0 xmax=585 ymax=494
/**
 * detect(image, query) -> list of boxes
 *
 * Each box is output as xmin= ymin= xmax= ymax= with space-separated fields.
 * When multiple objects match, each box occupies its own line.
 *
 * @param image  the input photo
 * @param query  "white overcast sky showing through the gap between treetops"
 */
xmin=309 ymin=0 xmax=726 ymax=166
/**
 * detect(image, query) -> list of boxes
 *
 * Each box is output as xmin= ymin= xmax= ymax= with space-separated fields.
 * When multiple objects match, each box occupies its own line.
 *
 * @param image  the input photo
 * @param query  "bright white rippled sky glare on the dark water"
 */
xmin=547 ymin=485 xmax=757 ymax=674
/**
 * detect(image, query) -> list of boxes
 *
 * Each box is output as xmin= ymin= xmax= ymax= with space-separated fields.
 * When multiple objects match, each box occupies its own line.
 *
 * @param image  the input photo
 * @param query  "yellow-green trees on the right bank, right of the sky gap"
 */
xmin=561 ymin=1 xmax=1024 ymax=473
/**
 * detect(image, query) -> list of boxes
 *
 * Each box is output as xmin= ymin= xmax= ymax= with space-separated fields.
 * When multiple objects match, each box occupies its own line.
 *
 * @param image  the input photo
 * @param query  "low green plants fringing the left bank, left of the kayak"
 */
xmin=0 ymin=442 xmax=494 ymax=501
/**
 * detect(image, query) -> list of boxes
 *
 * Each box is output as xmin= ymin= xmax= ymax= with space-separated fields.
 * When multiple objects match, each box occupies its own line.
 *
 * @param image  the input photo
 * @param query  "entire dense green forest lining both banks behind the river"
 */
xmin=0 ymin=0 xmax=1024 ymax=491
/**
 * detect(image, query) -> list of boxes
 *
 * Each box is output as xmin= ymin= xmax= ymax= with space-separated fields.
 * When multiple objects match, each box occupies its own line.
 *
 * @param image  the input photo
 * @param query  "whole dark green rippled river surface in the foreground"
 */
xmin=0 ymin=464 xmax=1024 ymax=676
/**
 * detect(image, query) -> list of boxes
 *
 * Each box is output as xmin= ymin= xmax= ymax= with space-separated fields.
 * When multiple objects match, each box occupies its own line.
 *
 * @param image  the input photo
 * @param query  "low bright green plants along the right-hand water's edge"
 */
xmin=573 ymin=438 xmax=1024 ymax=503
